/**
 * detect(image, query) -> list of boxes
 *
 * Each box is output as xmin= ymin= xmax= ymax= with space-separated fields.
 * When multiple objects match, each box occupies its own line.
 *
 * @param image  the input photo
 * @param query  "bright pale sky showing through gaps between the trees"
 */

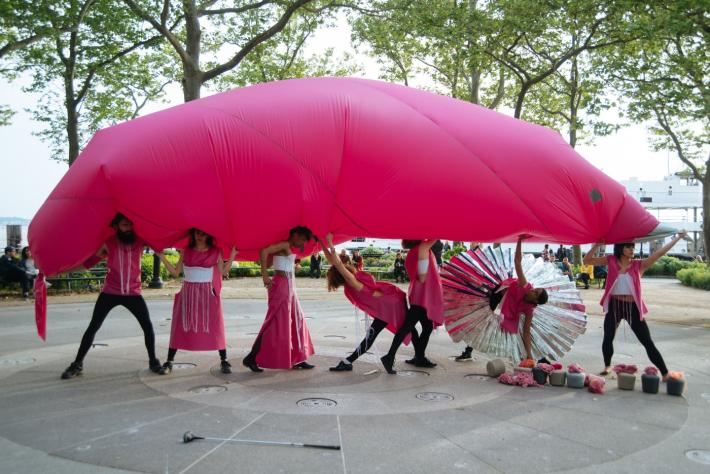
xmin=0 ymin=13 xmax=684 ymax=219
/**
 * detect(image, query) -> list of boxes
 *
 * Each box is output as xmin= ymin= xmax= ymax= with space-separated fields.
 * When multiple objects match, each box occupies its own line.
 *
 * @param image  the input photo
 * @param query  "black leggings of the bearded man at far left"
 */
xmin=75 ymin=293 xmax=155 ymax=365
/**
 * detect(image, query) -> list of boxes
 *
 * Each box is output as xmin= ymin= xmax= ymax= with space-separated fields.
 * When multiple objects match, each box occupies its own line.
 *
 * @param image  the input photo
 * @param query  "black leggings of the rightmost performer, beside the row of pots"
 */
xmin=602 ymin=297 xmax=668 ymax=375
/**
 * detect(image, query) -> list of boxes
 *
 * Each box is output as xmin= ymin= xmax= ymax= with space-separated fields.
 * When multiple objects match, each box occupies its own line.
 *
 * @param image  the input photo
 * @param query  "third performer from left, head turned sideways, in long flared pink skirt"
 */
xmin=242 ymin=226 xmax=314 ymax=372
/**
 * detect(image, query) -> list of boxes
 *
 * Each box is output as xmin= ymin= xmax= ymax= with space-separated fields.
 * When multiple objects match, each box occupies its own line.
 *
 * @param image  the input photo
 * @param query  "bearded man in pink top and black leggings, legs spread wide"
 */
xmin=62 ymin=214 xmax=160 ymax=379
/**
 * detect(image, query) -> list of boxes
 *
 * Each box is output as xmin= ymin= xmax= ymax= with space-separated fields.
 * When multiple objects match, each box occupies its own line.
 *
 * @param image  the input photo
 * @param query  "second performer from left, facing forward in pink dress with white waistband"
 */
xmin=159 ymin=228 xmax=237 ymax=375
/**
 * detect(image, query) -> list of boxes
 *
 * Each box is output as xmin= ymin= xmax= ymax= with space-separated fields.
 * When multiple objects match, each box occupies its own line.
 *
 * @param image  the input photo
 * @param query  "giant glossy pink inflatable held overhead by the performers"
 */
xmin=29 ymin=78 xmax=658 ymax=275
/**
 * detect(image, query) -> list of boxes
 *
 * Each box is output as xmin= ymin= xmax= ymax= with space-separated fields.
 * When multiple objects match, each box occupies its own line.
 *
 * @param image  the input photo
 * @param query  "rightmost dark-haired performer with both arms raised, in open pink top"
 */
xmin=584 ymin=232 xmax=686 ymax=381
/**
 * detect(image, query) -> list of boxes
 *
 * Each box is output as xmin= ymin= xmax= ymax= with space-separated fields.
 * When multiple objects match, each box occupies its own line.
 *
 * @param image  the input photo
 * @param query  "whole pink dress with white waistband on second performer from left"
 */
xmin=170 ymin=247 xmax=227 ymax=351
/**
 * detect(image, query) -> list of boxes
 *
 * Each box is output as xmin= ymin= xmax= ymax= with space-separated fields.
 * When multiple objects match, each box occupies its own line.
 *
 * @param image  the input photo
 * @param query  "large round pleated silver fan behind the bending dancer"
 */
xmin=441 ymin=247 xmax=587 ymax=360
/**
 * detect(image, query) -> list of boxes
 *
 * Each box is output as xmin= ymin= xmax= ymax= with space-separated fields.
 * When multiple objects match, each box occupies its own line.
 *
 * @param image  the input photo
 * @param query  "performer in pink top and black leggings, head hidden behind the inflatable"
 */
xmin=380 ymin=240 xmax=444 ymax=374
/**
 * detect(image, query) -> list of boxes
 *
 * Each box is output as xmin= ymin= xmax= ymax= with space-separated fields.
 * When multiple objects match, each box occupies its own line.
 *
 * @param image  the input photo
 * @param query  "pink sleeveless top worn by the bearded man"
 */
xmin=102 ymin=236 xmax=145 ymax=296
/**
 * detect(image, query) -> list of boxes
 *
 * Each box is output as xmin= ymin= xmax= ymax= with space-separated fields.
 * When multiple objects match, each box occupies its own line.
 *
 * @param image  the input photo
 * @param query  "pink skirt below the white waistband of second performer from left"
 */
xmin=170 ymin=282 xmax=227 ymax=351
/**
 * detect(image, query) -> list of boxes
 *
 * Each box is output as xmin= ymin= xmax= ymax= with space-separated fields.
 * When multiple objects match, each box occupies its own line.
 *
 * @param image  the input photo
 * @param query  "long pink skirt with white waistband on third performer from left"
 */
xmin=256 ymin=254 xmax=315 ymax=369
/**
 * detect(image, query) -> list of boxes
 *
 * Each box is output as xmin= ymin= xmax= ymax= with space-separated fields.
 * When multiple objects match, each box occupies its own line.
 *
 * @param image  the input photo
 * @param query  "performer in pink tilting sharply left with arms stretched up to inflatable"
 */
xmin=321 ymin=234 xmax=416 ymax=372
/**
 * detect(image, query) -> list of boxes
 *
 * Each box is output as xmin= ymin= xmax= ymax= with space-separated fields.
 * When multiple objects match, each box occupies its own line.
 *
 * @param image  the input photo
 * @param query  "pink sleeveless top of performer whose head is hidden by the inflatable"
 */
xmin=404 ymin=245 xmax=444 ymax=326
